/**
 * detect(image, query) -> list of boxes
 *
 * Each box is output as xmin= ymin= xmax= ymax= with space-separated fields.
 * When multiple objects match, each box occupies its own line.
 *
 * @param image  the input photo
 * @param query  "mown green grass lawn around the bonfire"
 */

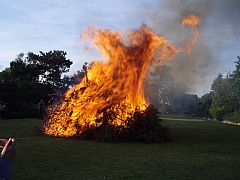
xmin=0 ymin=116 xmax=240 ymax=180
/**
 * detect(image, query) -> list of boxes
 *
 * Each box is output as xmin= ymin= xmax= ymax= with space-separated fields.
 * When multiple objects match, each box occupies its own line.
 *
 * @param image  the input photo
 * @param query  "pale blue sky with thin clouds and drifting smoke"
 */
xmin=0 ymin=0 xmax=240 ymax=97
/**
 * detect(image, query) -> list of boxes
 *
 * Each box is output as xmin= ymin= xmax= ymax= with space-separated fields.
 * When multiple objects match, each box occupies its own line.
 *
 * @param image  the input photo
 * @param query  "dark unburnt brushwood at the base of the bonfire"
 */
xmin=78 ymin=105 xmax=170 ymax=143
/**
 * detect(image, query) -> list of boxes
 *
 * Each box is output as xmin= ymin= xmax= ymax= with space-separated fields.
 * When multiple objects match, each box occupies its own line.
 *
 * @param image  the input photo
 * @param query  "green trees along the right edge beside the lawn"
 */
xmin=195 ymin=56 xmax=240 ymax=120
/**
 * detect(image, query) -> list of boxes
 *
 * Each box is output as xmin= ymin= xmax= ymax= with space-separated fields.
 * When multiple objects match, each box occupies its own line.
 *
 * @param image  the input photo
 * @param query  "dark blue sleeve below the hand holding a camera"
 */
xmin=0 ymin=157 xmax=13 ymax=180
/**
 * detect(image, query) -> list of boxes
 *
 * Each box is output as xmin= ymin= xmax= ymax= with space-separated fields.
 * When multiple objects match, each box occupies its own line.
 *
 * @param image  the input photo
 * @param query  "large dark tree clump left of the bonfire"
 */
xmin=0 ymin=50 xmax=73 ymax=118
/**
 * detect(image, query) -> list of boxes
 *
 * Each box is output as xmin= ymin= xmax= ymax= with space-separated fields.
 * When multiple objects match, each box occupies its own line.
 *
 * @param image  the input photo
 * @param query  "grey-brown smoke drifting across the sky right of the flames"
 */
xmin=149 ymin=0 xmax=240 ymax=95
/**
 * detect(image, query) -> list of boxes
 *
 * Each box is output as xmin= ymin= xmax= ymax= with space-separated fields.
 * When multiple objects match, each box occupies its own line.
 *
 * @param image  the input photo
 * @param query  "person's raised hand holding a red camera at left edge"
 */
xmin=1 ymin=138 xmax=17 ymax=160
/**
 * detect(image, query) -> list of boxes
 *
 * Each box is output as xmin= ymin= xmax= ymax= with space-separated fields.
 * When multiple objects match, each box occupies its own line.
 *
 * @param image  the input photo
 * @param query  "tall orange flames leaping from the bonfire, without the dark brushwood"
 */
xmin=43 ymin=14 xmax=201 ymax=137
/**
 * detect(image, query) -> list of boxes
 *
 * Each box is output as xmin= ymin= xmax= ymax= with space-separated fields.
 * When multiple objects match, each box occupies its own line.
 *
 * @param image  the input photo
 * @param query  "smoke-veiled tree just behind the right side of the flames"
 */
xmin=145 ymin=65 xmax=191 ymax=112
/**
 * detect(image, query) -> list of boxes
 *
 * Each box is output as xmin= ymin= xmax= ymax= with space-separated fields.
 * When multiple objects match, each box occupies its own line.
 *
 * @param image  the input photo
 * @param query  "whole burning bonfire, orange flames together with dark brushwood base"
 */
xmin=42 ymin=15 xmax=200 ymax=142
